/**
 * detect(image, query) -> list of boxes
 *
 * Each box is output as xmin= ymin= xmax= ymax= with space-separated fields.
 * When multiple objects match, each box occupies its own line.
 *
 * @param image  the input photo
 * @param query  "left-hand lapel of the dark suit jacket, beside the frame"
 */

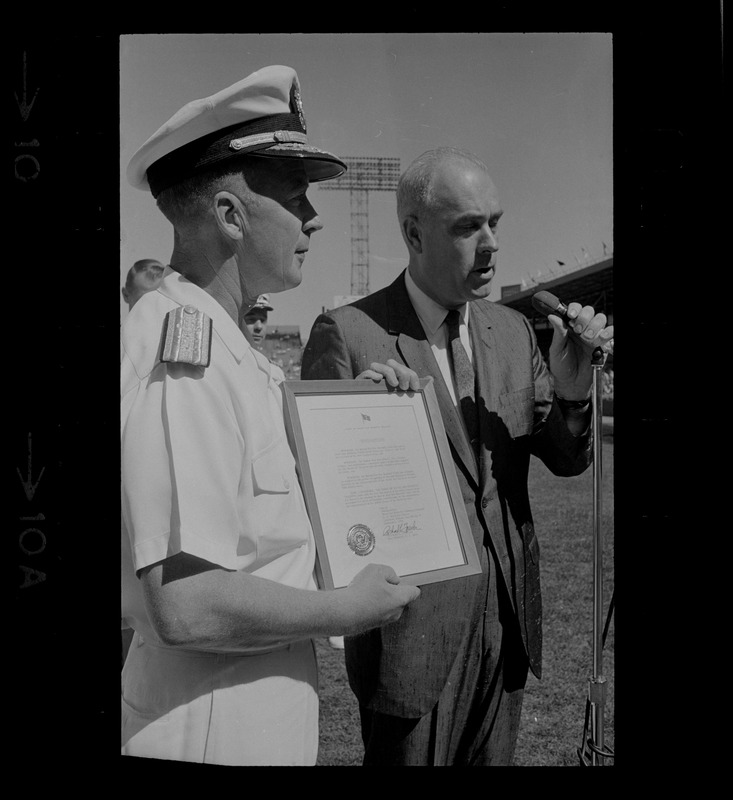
xmin=388 ymin=272 xmax=479 ymax=486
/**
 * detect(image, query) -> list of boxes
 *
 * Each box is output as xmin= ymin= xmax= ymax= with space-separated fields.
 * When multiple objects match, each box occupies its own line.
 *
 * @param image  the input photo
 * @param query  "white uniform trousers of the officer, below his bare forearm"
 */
xmin=122 ymin=633 xmax=318 ymax=766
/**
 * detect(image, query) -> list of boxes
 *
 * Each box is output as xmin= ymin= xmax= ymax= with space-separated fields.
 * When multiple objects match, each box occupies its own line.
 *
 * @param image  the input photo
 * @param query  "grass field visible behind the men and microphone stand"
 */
xmin=316 ymin=437 xmax=614 ymax=767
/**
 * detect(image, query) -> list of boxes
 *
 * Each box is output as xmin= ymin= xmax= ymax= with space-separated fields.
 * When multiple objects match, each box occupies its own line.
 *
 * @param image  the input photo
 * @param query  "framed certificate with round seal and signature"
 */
xmin=281 ymin=378 xmax=481 ymax=589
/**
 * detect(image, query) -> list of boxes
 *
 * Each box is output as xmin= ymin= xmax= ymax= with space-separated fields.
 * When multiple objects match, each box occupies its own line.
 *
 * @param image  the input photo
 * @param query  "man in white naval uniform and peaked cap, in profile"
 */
xmin=121 ymin=66 xmax=419 ymax=765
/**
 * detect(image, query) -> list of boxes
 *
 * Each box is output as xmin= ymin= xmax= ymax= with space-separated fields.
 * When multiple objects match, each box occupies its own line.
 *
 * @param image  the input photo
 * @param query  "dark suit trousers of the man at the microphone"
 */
xmin=360 ymin=556 xmax=528 ymax=767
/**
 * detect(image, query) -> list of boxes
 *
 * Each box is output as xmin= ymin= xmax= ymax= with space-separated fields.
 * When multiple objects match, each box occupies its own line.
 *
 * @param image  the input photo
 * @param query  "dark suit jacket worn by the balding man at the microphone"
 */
xmin=301 ymin=272 xmax=592 ymax=717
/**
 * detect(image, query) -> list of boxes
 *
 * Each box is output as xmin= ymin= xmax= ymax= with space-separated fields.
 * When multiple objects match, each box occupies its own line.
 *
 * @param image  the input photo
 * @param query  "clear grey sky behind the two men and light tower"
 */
xmin=120 ymin=33 xmax=613 ymax=340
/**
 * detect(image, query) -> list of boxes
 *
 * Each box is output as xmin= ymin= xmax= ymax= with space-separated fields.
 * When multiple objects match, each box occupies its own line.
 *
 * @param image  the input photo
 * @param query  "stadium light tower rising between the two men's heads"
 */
xmin=319 ymin=156 xmax=400 ymax=296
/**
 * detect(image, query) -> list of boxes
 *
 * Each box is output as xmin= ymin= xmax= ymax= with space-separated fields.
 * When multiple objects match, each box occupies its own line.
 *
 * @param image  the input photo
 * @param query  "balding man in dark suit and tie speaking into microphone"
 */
xmin=301 ymin=148 xmax=613 ymax=766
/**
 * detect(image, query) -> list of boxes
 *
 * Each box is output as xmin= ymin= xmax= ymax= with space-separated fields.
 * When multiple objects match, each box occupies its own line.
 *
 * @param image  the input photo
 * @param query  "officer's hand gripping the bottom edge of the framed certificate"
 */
xmin=340 ymin=564 xmax=420 ymax=636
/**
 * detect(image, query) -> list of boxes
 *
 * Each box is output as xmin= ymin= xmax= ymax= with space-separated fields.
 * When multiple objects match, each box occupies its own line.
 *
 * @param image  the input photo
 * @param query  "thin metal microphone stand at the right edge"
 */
xmin=578 ymin=347 xmax=614 ymax=767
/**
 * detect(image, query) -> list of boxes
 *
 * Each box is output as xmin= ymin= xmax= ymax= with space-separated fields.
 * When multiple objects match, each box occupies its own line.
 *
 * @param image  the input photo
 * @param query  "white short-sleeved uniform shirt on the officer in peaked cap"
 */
xmin=121 ymin=270 xmax=316 ymax=641
